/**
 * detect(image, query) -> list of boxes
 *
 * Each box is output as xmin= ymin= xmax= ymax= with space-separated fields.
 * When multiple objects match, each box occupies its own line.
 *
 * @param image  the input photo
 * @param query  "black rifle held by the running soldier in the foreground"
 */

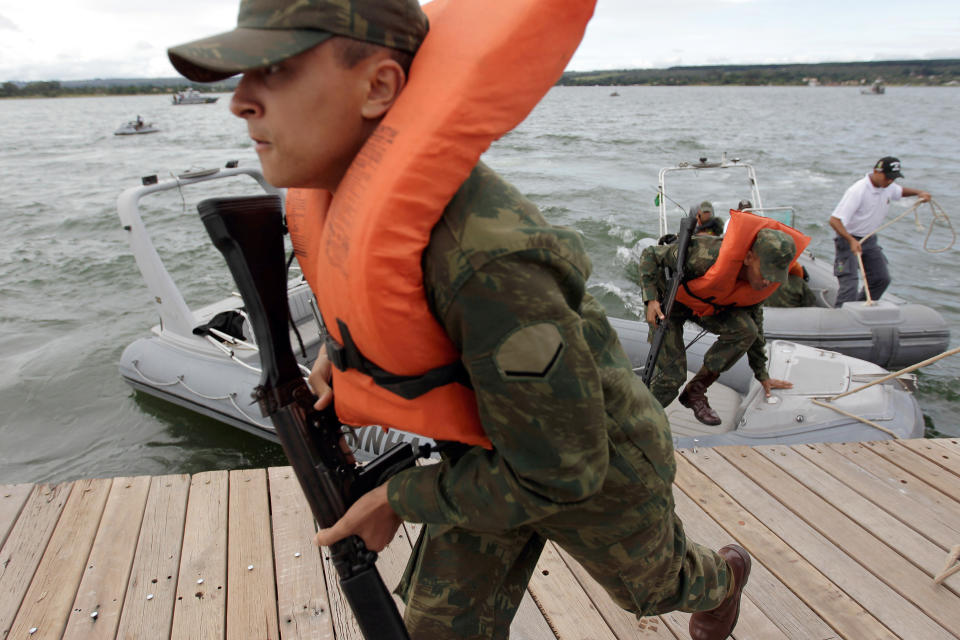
xmin=197 ymin=195 xmax=420 ymax=640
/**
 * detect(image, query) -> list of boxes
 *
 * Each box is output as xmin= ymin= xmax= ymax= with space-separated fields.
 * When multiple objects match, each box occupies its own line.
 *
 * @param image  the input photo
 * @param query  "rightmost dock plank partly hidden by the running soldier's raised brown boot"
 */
xmin=674 ymin=489 xmax=833 ymax=640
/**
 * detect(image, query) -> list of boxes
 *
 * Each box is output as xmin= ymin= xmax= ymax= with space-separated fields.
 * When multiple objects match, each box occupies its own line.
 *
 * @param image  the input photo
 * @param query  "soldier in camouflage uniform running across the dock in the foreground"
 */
xmin=171 ymin=0 xmax=750 ymax=640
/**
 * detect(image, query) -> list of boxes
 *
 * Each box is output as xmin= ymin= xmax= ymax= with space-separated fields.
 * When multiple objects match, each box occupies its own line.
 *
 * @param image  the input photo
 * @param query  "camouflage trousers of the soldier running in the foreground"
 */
xmin=396 ymin=437 xmax=730 ymax=640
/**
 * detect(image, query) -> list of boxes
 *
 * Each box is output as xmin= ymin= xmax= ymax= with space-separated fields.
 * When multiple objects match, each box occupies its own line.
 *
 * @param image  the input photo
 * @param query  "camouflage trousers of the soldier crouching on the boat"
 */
xmin=650 ymin=303 xmax=763 ymax=407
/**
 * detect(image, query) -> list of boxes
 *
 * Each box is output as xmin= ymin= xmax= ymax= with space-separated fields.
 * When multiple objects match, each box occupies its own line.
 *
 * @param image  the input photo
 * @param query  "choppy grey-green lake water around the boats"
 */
xmin=0 ymin=87 xmax=960 ymax=483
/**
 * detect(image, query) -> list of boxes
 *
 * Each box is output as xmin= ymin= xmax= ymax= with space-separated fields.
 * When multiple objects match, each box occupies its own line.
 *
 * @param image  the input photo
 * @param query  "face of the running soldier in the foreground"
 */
xmin=230 ymin=40 xmax=369 ymax=191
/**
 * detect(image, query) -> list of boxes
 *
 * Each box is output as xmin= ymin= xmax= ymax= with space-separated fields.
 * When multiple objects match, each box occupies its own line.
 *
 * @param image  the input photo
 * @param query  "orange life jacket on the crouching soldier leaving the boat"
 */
xmin=677 ymin=209 xmax=810 ymax=317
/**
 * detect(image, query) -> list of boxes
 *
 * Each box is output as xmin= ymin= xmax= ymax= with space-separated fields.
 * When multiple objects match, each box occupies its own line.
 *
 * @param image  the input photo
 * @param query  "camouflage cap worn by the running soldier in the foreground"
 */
xmin=167 ymin=0 xmax=429 ymax=82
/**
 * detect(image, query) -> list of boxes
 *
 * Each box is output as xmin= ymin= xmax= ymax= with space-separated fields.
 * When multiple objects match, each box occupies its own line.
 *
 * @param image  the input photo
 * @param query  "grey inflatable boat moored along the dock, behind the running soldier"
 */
xmin=118 ymin=163 xmax=923 ymax=461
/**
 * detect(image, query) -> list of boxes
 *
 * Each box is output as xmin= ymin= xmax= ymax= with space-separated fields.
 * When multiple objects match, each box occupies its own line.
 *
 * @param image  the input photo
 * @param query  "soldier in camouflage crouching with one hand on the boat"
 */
xmin=627 ymin=229 xmax=795 ymax=425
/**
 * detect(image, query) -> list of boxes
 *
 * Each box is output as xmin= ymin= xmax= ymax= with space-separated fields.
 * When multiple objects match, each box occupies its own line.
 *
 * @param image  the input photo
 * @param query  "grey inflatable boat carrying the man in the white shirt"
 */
xmin=628 ymin=154 xmax=950 ymax=369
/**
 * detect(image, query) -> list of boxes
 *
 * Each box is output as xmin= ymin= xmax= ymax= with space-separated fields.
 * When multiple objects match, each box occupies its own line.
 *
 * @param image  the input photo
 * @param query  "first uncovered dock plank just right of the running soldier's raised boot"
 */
xmin=676 ymin=449 xmax=897 ymax=640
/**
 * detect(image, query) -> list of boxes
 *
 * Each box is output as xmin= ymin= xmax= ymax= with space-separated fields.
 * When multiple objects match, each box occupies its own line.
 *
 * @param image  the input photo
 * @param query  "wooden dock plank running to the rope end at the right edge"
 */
xmin=755 ymin=446 xmax=960 ymax=593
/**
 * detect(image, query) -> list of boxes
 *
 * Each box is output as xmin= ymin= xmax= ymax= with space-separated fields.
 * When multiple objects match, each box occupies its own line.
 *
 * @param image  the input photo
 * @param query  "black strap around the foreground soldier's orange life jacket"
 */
xmin=326 ymin=318 xmax=473 ymax=400
